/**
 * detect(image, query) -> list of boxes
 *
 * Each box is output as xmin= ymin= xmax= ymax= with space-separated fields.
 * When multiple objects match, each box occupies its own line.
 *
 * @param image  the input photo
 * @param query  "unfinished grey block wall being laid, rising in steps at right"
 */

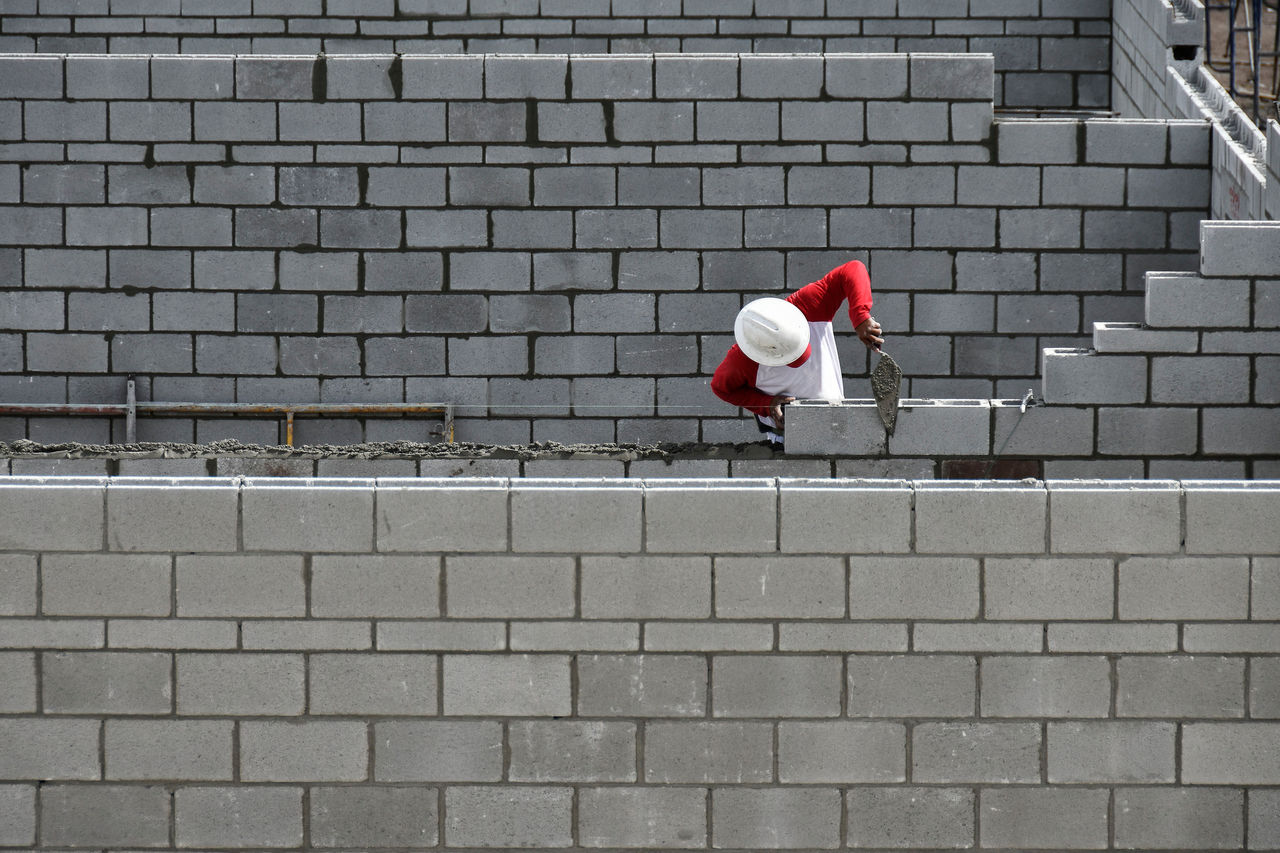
xmin=787 ymin=220 xmax=1280 ymax=479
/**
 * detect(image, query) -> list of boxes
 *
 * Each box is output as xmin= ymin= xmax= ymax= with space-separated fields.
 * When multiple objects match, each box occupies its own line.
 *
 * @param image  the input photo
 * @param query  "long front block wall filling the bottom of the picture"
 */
xmin=0 ymin=476 xmax=1280 ymax=850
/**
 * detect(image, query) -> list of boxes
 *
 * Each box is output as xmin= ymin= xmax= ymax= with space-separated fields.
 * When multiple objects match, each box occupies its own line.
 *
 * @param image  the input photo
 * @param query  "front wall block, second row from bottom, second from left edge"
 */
xmin=104 ymin=720 xmax=234 ymax=781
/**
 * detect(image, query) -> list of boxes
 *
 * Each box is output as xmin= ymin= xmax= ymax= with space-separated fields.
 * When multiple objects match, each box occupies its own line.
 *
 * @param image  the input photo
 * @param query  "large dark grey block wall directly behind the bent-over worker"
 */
xmin=0 ymin=54 xmax=1208 ymax=443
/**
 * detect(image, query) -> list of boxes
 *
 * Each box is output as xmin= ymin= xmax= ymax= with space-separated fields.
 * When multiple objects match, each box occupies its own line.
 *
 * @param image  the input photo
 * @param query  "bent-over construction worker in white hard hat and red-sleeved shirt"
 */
xmin=712 ymin=261 xmax=884 ymax=447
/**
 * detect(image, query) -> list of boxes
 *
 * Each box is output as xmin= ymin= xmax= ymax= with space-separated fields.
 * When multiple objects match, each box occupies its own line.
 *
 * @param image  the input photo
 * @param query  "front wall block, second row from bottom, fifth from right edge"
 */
xmin=644 ymin=722 xmax=773 ymax=784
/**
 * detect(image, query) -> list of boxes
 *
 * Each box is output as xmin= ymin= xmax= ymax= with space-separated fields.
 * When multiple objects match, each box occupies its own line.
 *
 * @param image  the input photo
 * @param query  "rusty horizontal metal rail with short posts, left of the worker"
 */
xmin=0 ymin=379 xmax=453 ymax=447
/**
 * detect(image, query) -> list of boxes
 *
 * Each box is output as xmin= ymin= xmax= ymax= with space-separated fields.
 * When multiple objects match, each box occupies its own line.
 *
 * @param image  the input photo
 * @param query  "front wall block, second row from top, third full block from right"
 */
xmin=849 ymin=555 xmax=978 ymax=619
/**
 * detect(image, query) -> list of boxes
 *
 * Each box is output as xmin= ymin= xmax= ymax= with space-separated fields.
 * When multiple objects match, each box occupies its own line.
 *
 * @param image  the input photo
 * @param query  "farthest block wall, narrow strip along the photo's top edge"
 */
xmin=0 ymin=0 xmax=1111 ymax=109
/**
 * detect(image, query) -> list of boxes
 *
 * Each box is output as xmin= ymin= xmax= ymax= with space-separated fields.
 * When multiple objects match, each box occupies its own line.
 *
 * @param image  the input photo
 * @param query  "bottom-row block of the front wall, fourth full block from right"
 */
xmin=712 ymin=788 xmax=841 ymax=849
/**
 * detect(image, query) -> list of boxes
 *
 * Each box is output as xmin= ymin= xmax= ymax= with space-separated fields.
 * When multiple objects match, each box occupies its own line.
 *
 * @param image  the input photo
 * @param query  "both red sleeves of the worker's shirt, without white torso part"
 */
xmin=712 ymin=260 xmax=872 ymax=415
